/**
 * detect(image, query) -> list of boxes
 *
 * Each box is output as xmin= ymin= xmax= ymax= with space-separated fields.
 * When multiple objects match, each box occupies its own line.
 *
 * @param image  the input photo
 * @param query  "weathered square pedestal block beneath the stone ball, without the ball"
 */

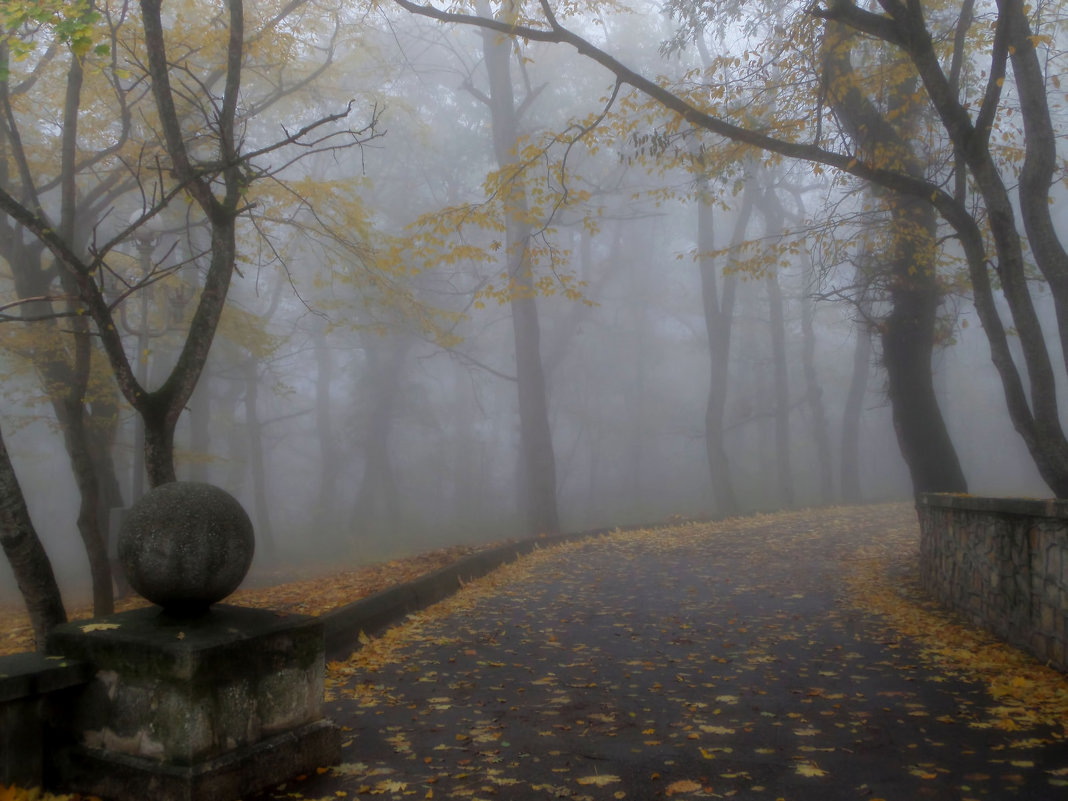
xmin=48 ymin=604 xmax=340 ymax=801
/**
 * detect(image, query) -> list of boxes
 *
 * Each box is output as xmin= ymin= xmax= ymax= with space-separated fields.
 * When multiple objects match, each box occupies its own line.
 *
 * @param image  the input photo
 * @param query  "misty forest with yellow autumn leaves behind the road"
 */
xmin=0 ymin=0 xmax=1068 ymax=632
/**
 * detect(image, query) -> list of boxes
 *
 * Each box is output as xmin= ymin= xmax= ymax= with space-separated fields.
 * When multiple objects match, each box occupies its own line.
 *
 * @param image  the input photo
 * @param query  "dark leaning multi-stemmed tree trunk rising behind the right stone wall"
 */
xmin=826 ymin=0 xmax=1068 ymax=498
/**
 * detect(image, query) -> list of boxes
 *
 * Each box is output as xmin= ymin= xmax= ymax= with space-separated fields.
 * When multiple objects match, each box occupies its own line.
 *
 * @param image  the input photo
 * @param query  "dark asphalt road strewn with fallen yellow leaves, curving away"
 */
xmin=247 ymin=507 xmax=1068 ymax=801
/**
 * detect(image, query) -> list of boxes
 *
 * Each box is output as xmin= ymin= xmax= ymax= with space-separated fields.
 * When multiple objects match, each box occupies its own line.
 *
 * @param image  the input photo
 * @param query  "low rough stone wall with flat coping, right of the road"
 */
xmin=916 ymin=493 xmax=1068 ymax=671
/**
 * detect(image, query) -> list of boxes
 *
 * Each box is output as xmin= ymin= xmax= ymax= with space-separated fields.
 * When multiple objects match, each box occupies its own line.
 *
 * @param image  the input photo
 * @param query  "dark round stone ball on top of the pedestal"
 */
xmin=119 ymin=482 xmax=255 ymax=617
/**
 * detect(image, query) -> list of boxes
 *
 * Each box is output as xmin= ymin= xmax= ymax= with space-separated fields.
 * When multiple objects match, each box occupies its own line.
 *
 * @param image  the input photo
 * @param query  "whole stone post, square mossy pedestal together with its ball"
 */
xmin=48 ymin=483 xmax=341 ymax=801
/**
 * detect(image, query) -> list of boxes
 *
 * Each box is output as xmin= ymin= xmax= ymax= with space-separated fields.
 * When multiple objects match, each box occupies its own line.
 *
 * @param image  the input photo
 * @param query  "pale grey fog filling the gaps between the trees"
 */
xmin=0 ymin=1 xmax=1057 ymax=601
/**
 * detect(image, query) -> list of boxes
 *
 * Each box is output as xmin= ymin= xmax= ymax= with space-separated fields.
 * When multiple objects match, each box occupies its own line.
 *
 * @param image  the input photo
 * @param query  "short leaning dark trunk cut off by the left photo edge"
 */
xmin=0 ymin=420 xmax=66 ymax=653
